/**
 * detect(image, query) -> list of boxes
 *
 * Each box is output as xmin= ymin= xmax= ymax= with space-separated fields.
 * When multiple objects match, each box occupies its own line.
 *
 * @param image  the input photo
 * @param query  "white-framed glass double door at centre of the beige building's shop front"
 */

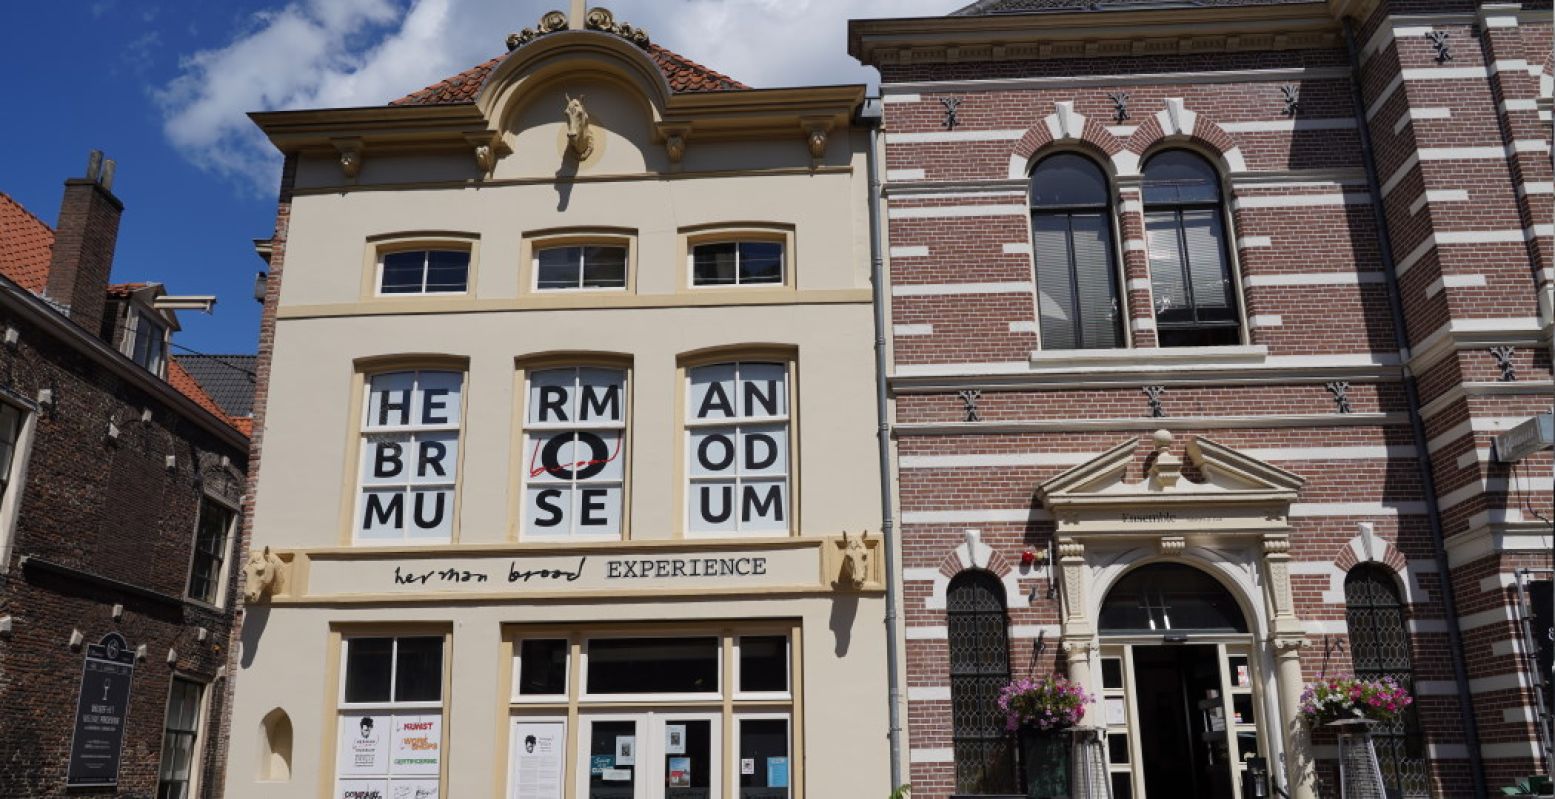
xmin=578 ymin=712 xmax=723 ymax=799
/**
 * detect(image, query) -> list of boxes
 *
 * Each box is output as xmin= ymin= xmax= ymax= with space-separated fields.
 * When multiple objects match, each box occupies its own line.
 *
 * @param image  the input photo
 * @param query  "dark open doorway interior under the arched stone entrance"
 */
xmin=1134 ymin=644 xmax=1232 ymax=799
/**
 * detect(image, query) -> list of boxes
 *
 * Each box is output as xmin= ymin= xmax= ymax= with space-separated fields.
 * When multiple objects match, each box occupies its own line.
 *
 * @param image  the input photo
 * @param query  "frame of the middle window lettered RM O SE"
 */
xmin=508 ymin=360 xmax=636 ymax=544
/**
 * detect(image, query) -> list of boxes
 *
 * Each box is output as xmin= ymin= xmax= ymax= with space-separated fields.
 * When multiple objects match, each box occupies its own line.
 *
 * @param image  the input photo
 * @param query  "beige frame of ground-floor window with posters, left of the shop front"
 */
xmin=320 ymin=622 xmax=454 ymax=796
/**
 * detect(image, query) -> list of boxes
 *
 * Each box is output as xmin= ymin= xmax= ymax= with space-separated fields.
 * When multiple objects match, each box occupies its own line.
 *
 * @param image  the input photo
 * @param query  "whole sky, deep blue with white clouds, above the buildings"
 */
xmin=0 ymin=0 xmax=945 ymax=353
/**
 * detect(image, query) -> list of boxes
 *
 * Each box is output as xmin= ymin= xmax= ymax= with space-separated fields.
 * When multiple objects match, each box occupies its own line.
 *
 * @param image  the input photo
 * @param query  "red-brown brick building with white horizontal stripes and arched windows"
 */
xmin=849 ymin=0 xmax=1555 ymax=799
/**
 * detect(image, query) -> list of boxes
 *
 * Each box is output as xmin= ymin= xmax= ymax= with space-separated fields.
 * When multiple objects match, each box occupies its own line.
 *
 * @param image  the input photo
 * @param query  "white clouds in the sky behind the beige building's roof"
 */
xmin=156 ymin=0 xmax=964 ymax=193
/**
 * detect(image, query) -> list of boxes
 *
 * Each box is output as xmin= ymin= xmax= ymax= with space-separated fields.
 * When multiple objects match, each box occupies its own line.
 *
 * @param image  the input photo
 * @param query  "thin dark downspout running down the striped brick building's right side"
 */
xmin=1344 ymin=17 xmax=1485 ymax=789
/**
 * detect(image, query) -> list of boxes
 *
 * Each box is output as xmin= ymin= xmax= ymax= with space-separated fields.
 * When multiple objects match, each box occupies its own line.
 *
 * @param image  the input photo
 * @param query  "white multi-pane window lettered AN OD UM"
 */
xmin=686 ymin=362 xmax=790 ymax=533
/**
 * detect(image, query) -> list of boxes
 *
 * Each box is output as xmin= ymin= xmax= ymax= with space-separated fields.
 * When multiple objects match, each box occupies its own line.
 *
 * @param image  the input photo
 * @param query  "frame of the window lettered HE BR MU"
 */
xmin=339 ymin=354 xmax=470 ymax=549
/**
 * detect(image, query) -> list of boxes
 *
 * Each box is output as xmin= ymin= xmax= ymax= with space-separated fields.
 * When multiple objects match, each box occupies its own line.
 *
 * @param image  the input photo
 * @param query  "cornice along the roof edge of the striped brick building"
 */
xmin=847 ymin=3 xmax=1342 ymax=67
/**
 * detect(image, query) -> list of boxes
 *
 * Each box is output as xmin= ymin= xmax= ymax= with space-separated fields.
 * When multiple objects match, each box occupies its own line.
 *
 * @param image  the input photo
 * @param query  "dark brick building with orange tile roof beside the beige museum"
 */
xmin=0 ymin=154 xmax=247 ymax=799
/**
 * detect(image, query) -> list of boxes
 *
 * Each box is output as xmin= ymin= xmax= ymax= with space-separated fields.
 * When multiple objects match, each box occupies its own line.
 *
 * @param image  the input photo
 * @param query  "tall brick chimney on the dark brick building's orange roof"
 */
xmin=44 ymin=149 xmax=124 ymax=334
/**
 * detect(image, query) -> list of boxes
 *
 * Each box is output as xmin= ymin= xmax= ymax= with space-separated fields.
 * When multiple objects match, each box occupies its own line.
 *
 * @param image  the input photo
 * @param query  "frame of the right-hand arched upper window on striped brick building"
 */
xmin=1138 ymin=145 xmax=1252 ymax=350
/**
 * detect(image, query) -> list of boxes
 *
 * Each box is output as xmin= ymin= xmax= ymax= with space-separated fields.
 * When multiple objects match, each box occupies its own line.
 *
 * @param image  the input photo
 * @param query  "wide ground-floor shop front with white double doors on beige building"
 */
xmin=508 ymin=625 xmax=798 ymax=799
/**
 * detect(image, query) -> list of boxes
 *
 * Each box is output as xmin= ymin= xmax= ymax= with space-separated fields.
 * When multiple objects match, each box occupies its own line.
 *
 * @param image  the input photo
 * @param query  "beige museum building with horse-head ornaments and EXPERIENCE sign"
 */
xmin=227 ymin=8 xmax=889 ymax=799
